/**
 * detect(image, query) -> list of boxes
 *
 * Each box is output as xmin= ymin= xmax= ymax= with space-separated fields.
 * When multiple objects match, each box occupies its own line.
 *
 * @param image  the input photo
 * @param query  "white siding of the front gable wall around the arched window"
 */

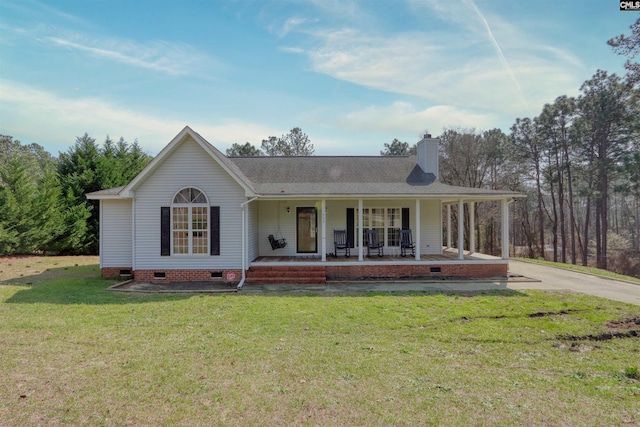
xmin=135 ymin=138 xmax=246 ymax=270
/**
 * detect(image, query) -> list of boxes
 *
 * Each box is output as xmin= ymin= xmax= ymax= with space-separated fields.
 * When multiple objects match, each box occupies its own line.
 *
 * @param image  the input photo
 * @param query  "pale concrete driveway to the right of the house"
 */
xmin=507 ymin=260 xmax=640 ymax=305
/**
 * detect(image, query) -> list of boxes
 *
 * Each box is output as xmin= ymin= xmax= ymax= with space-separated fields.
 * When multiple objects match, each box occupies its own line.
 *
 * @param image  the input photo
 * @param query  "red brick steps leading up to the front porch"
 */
xmin=245 ymin=265 xmax=327 ymax=285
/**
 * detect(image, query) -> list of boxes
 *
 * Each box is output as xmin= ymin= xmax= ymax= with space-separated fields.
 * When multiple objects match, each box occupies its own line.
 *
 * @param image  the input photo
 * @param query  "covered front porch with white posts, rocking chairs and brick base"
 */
xmin=244 ymin=196 xmax=511 ymax=284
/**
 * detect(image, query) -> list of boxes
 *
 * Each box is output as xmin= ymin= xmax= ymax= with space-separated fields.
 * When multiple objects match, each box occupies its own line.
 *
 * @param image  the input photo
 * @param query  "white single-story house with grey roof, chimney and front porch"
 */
xmin=87 ymin=126 xmax=520 ymax=287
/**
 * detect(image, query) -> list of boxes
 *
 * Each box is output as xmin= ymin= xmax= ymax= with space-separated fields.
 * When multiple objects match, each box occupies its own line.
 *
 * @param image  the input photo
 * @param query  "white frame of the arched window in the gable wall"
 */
xmin=171 ymin=186 xmax=211 ymax=256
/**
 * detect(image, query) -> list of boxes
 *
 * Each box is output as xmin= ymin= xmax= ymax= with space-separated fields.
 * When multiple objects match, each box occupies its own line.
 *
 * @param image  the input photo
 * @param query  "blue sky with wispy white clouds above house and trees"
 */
xmin=0 ymin=0 xmax=639 ymax=156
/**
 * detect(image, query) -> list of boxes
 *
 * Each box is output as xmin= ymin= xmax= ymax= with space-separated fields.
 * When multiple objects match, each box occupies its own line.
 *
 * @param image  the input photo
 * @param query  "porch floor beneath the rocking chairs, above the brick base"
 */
xmin=251 ymin=248 xmax=506 ymax=267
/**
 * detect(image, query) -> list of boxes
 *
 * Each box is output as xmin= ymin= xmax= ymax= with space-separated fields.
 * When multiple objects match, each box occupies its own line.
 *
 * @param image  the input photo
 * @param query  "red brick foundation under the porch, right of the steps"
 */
xmin=326 ymin=264 xmax=507 ymax=280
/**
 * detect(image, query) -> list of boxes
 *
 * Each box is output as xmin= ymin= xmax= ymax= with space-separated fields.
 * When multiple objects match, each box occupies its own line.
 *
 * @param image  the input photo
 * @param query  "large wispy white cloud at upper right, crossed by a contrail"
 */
xmin=282 ymin=0 xmax=581 ymax=118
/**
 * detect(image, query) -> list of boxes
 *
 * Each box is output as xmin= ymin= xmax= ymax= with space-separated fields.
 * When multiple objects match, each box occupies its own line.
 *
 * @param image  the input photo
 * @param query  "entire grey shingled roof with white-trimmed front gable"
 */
xmin=87 ymin=126 xmax=522 ymax=200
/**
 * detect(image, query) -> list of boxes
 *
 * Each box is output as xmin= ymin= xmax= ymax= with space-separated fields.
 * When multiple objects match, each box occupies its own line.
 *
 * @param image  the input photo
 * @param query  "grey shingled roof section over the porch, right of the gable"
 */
xmin=229 ymin=156 xmax=520 ymax=199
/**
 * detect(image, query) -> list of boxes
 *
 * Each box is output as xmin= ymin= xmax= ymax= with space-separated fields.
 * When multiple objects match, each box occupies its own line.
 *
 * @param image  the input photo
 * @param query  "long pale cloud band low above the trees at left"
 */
xmin=0 ymin=80 xmax=277 ymax=154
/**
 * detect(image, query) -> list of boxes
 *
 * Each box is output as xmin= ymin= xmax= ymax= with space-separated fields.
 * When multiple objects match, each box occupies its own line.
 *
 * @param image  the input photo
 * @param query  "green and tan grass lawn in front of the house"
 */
xmin=0 ymin=260 xmax=640 ymax=426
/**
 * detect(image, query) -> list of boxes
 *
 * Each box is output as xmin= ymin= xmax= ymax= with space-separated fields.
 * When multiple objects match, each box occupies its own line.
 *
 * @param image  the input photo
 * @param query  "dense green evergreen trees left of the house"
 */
xmin=0 ymin=133 xmax=151 ymax=255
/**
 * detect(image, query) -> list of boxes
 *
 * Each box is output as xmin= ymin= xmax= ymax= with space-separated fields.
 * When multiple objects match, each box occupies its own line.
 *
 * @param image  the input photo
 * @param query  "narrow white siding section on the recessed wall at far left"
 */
xmin=100 ymin=200 xmax=133 ymax=268
